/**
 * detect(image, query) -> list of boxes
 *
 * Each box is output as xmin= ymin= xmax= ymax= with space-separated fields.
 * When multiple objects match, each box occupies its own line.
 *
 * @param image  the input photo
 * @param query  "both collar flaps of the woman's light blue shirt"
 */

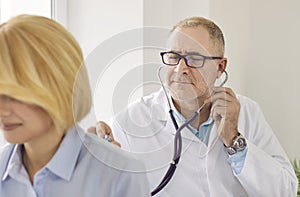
xmin=2 ymin=125 xmax=85 ymax=181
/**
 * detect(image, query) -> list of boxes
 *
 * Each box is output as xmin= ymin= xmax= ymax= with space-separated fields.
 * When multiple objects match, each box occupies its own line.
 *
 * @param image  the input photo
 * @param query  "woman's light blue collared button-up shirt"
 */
xmin=0 ymin=125 xmax=150 ymax=197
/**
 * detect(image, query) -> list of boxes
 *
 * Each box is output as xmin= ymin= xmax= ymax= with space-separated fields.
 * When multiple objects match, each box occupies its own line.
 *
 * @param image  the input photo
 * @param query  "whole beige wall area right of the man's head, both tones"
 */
xmin=210 ymin=0 xmax=300 ymax=158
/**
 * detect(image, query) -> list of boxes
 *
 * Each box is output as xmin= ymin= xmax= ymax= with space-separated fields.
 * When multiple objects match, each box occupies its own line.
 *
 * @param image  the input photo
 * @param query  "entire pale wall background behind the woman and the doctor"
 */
xmin=0 ymin=0 xmax=300 ymax=159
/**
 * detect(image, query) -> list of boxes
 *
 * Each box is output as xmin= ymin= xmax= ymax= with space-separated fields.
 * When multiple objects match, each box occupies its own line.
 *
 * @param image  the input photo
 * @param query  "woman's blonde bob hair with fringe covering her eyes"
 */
xmin=0 ymin=15 xmax=91 ymax=132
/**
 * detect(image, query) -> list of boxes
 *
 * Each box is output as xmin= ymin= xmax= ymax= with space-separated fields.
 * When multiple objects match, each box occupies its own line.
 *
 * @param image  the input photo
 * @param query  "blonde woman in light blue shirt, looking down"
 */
xmin=0 ymin=15 xmax=150 ymax=197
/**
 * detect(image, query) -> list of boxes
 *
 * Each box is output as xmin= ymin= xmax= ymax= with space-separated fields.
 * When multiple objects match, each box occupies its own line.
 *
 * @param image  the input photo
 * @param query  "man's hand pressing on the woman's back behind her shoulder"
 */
xmin=87 ymin=121 xmax=121 ymax=147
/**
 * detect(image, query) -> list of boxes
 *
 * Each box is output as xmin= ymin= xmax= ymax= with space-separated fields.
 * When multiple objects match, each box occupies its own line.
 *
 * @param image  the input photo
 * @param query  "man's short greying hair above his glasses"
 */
xmin=171 ymin=16 xmax=225 ymax=56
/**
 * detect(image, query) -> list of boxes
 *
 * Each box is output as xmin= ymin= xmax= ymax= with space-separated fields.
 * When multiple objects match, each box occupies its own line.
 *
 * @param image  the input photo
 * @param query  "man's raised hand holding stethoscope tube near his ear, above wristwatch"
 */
xmin=208 ymin=87 xmax=240 ymax=147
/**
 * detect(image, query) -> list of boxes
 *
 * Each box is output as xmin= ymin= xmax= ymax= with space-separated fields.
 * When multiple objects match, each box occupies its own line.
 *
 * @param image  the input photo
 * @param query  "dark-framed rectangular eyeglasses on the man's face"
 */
xmin=160 ymin=51 xmax=222 ymax=68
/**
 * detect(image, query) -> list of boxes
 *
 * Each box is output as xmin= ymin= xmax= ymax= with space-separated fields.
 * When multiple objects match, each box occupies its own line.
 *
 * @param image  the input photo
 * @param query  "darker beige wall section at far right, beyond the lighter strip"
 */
xmin=247 ymin=0 xmax=300 ymax=158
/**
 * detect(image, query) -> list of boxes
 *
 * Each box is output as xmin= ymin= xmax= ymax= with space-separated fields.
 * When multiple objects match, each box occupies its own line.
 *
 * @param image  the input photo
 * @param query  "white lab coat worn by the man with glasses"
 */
xmin=111 ymin=90 xmax=298 ymax=197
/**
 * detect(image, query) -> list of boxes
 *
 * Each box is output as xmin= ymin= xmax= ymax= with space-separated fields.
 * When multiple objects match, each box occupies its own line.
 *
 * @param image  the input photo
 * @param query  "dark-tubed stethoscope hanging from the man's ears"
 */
xmin=151 ymin=65 xmax=228 ymax=196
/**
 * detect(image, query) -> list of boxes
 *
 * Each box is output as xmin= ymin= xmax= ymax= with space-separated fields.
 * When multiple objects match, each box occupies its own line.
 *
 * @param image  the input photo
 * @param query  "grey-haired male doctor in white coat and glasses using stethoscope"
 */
xmin=91 ymin=17 xmax=297 ymax=197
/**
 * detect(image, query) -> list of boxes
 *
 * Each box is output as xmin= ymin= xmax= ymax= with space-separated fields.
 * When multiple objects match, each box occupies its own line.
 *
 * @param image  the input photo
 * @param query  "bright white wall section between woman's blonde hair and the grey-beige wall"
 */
xmin=67 ymin=0 xmax=143 ymax=128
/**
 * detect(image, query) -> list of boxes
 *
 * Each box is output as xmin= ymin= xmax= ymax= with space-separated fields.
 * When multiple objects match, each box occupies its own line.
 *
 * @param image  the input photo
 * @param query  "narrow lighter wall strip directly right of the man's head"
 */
xmin=209 ymin=0 xmax=251 ymax=94
